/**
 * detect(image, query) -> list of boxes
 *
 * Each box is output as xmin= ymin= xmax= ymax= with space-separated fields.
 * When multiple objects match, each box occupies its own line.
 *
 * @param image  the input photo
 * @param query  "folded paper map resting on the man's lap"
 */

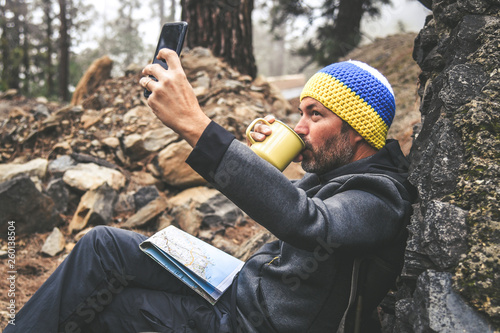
xmin=140 ymin=226 xmax=243 ymax=304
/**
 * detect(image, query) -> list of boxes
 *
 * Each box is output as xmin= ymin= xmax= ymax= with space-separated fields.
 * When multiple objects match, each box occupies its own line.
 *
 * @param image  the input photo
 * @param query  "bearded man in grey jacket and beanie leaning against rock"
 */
xmin=5 ymin=49 xmax=414 ymax=333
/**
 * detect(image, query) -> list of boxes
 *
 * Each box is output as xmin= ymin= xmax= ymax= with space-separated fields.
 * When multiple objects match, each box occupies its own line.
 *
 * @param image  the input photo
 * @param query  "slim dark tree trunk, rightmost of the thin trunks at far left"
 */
xmin=59 ymin=0 xmax=70 ymax=101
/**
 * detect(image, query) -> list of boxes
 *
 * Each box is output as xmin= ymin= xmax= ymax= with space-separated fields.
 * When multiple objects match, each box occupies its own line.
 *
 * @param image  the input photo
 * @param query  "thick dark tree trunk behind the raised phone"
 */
xmin=181 ymin=0 xmax=257 ymax=78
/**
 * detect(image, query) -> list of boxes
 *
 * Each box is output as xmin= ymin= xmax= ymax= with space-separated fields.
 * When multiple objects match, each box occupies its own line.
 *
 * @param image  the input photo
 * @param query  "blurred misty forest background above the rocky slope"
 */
xmin=0 ymin=0 xmax=429 ymax=101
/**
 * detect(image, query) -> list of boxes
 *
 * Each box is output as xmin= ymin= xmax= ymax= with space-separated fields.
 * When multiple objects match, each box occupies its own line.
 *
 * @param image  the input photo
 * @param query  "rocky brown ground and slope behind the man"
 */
xmin=0 ymin=34 xmax=420 ymax=327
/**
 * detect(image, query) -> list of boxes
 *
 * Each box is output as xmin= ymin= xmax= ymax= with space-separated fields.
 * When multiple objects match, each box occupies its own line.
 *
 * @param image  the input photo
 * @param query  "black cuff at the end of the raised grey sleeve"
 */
xmin=186 ymin=121 xmax=235 ymax=182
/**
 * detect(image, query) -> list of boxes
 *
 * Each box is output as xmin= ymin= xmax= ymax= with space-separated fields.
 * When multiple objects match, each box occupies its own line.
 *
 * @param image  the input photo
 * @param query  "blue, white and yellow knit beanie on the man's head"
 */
xmin=300 ymin=60 xmax=396 ymax=149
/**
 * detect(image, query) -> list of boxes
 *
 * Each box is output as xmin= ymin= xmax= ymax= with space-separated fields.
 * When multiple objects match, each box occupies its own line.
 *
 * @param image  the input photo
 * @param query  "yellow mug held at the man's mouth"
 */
xmin=246 ymin=118 xmax=306 ymax=171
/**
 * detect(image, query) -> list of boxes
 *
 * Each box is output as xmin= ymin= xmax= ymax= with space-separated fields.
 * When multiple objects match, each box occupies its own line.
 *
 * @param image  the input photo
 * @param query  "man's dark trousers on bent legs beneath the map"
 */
xmin=4 ymin=227 xmax=231 ymax=333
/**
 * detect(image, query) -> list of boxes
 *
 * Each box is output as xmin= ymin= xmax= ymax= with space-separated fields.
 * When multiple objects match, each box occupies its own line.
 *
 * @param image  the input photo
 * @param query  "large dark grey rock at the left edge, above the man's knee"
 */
xmin=0 ymin=176 xmax=62 ymax=235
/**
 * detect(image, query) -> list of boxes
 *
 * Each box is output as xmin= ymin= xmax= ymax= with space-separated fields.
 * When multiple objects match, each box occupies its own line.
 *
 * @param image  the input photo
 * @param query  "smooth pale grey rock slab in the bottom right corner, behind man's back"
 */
xmin=410 ymin=270 xmax=493 ymax=333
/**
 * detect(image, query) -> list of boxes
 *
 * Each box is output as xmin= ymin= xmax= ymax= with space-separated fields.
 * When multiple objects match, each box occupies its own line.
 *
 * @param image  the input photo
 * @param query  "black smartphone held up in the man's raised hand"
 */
xmin=144 ymin=21 xmax=188 ymax=98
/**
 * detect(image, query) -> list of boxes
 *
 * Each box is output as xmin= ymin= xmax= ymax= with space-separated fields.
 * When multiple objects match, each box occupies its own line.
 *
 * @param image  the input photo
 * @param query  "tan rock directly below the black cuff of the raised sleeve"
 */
xmin=158 ymin=140 xmax=206 ymax=188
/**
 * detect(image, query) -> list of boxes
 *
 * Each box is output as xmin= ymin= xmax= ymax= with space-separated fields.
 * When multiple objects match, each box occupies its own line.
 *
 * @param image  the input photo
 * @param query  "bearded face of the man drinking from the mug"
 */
xmin=295 ymin=97 xmax=354 ymax=174
